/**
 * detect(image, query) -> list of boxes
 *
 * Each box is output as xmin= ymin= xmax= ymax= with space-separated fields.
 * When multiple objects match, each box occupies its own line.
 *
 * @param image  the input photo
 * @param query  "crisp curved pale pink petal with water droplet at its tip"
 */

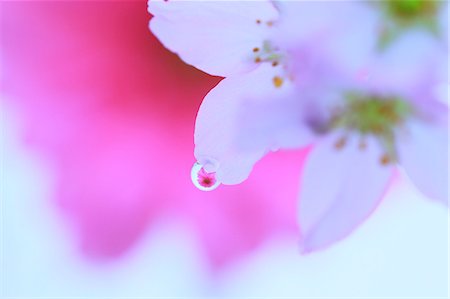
xmin=195 ymin=65 xmax=290 ymax=184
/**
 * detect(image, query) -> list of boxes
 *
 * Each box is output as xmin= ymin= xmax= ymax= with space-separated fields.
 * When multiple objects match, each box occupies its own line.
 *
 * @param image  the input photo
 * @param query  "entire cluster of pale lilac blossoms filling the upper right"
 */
xmin=149 ymin=0 xmax=448 ymax=252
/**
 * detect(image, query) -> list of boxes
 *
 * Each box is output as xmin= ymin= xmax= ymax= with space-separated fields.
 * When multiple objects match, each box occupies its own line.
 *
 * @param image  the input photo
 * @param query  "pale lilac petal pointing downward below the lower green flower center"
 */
xmin=299 ymin=135 xmax=392 ymax=252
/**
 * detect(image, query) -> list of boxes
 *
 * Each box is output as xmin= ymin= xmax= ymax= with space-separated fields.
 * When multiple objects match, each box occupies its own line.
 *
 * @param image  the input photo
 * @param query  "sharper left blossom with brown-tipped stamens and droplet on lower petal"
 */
xmin=149 ymin=1 xmax=382 ymax=184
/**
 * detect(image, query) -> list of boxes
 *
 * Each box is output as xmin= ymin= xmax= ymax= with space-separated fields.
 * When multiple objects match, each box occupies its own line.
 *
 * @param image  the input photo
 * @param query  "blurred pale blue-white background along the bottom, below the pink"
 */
xmin=1 ymin=101 xmax=449 ymax=298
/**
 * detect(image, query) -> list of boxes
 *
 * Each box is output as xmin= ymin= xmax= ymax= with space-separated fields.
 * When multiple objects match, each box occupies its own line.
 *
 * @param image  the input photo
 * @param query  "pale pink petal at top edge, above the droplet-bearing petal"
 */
xmin=148 ymin=0 xmax=278 ymax=77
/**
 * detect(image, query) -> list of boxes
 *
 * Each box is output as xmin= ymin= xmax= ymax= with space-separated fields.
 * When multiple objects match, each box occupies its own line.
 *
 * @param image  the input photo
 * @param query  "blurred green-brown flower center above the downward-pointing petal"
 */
xmin=330 ymin=93 xmax=413 ymax=165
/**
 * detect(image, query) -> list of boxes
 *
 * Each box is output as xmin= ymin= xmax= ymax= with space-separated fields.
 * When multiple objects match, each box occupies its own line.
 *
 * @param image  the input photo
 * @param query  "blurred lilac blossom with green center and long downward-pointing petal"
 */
xmin=299 ymin=32 xmax=448 ymax=251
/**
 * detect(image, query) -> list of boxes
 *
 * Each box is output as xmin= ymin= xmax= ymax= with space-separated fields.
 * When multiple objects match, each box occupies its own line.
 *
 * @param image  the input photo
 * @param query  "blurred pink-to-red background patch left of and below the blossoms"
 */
xmin=2 ymin=1 xmax=303 ymax=268
